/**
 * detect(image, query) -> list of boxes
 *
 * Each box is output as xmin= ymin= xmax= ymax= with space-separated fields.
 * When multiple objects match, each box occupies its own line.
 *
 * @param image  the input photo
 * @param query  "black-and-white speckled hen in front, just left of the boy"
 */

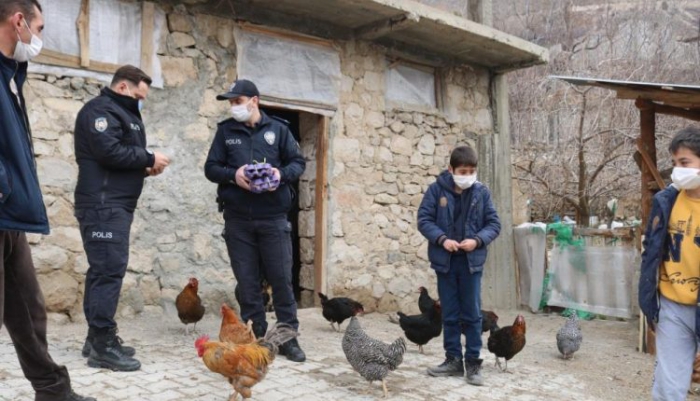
xmin=343 ymin=316 xmax=406 ymax=398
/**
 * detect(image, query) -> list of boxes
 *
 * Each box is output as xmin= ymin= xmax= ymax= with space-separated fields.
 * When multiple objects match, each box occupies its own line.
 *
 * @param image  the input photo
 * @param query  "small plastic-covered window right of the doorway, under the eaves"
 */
xmin=386 ymin=64 xmax=437 ymax=111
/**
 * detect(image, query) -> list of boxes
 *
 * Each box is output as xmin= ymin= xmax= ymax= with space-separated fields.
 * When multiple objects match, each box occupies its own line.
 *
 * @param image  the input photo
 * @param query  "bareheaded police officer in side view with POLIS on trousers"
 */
xmin=75 ymin=65 xmax=169 ymax=371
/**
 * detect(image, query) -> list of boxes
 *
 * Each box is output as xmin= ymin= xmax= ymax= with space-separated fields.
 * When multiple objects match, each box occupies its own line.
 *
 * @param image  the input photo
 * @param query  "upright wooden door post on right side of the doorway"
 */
xmin=314 ymin=116 xmax=329 ymax=305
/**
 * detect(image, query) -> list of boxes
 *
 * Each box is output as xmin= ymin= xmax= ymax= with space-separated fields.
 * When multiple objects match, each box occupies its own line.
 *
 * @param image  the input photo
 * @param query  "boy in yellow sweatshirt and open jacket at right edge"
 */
xmin=639 ymin=128 xmax=700 ymax=401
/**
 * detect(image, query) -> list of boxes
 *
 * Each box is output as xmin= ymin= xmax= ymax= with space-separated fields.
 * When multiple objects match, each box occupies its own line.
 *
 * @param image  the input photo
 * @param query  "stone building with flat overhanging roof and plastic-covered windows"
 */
xmin=25 ymin=0 xmax=548 ymax=319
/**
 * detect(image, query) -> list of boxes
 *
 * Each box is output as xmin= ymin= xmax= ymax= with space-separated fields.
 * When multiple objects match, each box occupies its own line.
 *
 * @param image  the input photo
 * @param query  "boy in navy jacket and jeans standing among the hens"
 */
xmin=418 ymin=146 xmax=501 ymax=386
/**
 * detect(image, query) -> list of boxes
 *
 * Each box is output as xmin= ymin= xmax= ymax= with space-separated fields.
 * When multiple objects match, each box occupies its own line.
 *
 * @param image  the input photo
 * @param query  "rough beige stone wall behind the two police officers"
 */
xmin=25 ymin=5 xmax=492 ymax=320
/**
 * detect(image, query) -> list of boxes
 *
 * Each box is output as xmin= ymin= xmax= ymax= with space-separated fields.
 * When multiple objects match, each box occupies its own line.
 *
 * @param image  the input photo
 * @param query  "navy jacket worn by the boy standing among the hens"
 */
xmin=418 ymin=171 xmax=501 ymax=273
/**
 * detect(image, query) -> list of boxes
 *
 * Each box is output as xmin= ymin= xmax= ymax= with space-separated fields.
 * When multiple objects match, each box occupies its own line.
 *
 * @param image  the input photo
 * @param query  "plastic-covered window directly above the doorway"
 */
xmin=235 ymin=29 xmax=341 ymax=110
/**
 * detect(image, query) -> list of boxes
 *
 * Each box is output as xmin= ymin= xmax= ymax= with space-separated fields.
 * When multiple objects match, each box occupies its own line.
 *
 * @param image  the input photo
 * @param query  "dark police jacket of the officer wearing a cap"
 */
xmin=204 ymin=112 xmax=306 ymax=219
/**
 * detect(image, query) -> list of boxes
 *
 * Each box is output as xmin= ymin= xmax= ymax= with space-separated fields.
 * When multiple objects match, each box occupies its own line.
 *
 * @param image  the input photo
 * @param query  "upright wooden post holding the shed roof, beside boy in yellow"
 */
xmin=635 ymin=101 xmax=663 ymax=354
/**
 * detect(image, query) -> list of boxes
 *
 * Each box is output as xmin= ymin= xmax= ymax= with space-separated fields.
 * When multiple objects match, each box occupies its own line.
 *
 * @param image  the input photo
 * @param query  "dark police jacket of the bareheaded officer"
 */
xmin=75 ymin=88 xmax=155 ymax=212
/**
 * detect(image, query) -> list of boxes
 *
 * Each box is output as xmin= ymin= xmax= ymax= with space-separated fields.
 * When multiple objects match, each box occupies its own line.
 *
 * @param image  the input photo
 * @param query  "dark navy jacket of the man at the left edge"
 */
xmin=0 ymin=53 xmax=49 ymax=234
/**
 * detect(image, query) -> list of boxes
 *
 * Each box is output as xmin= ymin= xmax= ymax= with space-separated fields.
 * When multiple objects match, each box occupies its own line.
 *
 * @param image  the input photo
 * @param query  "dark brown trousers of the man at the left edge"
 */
xmin=0 ymin=231 xmax=71 ymax=401
